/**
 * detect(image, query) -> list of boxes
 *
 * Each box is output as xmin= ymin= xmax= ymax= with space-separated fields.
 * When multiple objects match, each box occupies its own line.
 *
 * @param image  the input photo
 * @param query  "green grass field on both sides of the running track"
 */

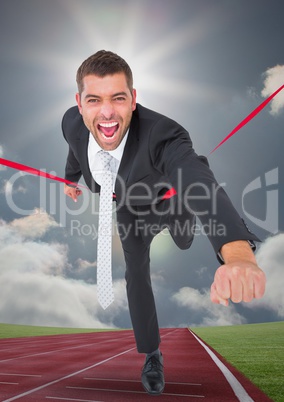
xmin=0 ymin=322 xmax=284 ymax=402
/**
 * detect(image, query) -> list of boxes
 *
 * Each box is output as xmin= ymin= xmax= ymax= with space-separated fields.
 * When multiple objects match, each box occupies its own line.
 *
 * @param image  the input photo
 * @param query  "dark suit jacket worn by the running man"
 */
xmin=62 ymin=104 xmax=259 ymax=252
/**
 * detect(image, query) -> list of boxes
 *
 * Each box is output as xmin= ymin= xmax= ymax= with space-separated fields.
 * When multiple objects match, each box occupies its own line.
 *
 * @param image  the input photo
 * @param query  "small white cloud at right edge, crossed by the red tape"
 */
xmin=261 ymin=65 xmax=284 ymax=116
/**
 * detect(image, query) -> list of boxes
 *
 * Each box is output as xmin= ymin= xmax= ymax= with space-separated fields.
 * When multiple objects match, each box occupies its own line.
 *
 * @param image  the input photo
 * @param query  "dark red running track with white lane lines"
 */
xmin=0 ymin=328 xmax=271 ymax=402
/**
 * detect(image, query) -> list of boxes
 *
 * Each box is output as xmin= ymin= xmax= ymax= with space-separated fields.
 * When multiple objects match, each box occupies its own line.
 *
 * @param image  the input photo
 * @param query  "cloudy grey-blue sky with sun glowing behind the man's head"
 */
xmin=0 ymin=0 xmax=284 ymax=328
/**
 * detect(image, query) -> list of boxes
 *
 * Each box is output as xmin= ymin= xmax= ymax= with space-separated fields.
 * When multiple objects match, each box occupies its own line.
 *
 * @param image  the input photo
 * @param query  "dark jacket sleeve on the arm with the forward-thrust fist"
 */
xmin=151 ymin=119 xmax=260 ymax=262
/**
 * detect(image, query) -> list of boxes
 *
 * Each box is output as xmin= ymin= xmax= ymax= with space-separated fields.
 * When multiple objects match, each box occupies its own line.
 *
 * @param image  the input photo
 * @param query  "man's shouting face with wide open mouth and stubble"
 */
xmin=76 ymin=73 xmax=136 ymax=151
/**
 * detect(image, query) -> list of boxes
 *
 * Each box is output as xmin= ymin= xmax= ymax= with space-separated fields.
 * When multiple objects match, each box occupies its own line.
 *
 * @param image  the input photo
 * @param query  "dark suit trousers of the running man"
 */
xmin=117 ymin=197 xmax=195 ymax=353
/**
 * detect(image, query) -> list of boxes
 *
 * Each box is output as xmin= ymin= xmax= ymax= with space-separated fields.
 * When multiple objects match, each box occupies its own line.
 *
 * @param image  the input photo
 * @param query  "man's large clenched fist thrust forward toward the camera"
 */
xmin=211 ymin=241 xmax=266 ymax=306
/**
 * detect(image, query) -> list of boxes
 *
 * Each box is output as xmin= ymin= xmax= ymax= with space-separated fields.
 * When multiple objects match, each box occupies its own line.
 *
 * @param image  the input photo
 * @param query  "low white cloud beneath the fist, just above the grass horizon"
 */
xmin=172 ymin=287 xmax=246 ymax=326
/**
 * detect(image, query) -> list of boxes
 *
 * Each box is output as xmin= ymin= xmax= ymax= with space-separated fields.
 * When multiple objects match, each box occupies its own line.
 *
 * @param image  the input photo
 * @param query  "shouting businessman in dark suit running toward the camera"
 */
xmin=62 ymin=50 xmax=265 ymax=395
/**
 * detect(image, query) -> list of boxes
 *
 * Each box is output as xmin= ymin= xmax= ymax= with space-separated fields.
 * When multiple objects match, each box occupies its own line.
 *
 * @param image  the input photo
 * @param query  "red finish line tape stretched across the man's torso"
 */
xmin=0 ymin=85 xmax=284 ymax=188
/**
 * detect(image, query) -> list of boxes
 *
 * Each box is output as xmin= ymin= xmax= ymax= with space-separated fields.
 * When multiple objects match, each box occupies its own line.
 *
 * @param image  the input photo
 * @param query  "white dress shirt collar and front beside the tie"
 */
xmin=88 ymin=130 xmax=129 ymax=190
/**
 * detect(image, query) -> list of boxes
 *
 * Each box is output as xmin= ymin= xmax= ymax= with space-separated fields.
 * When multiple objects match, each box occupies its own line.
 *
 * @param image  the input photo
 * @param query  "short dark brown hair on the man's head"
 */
xmin=76 ymin=50 xmax=133 ymax=95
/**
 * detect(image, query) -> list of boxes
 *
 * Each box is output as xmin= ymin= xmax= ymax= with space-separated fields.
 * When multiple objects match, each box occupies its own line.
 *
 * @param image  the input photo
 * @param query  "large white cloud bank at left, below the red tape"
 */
xmin=0 ymin=211 xmax=127 ymax=328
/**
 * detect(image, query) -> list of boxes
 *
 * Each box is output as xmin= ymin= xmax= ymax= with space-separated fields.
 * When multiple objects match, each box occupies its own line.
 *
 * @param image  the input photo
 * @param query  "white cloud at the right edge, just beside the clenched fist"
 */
xmin=246 ymin=233 xmax=284 ymax=319
